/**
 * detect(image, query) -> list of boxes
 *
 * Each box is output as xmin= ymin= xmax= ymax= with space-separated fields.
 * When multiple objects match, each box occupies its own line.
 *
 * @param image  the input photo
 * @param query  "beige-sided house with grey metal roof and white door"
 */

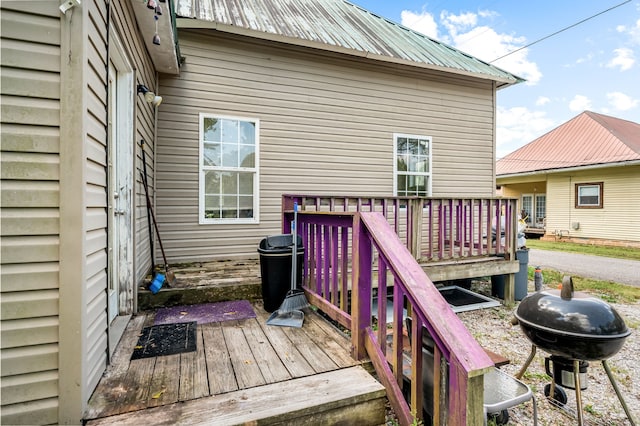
xmin=1 ymin=0 xmax=520 ymax=424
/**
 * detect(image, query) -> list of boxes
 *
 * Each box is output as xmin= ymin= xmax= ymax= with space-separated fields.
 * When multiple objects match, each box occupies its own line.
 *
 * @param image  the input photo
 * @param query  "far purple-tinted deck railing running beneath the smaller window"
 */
xmin=282 ymin=194 xmax=518 ymax=262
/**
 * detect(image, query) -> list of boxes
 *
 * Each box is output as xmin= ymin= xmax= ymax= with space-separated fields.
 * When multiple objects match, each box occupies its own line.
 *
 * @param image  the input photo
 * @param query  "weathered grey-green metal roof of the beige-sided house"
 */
xmin=175 ymin=0 xmax=524 ymax=87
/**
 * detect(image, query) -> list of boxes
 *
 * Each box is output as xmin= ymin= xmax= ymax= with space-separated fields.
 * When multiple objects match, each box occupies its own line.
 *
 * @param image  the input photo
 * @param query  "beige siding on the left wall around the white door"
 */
xmin=0 ymin=0 xmax=160 ymax=424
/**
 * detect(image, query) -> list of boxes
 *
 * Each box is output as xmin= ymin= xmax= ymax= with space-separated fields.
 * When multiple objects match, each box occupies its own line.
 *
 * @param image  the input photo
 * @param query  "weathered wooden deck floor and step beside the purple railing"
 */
xmin=85 ymin=303 xmax=385 ymax=425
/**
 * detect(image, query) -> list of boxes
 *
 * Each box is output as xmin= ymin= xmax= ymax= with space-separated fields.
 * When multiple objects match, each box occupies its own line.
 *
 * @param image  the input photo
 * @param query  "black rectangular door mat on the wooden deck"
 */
xmin=131 ymin=321 xmax=198 ymax=360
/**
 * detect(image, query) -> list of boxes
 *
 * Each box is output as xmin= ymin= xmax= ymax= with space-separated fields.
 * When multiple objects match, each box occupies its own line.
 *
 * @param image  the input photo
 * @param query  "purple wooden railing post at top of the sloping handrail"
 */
xmin=351 ymin=213 xmax=373 ymax=359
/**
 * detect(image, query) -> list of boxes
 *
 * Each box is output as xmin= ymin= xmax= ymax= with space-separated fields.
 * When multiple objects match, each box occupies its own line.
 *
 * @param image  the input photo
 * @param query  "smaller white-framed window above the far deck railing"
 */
xmin=393 ymin=134 xmax=431 ymax=197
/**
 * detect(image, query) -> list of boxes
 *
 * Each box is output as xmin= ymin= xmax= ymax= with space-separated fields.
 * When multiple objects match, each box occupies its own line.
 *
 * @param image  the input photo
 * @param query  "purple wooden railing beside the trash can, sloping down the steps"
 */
xmin=284 ymin=209 xmax=493 ymax=425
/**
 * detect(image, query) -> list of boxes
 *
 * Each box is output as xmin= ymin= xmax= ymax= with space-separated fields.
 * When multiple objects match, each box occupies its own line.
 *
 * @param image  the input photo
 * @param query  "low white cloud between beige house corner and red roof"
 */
xmin=496 ymin=107 xmax=554 ymax=158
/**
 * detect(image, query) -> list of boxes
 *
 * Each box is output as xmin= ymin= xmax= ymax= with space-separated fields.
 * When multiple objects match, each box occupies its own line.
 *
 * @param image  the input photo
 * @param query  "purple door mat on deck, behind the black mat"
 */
xmin=154 ymin=300 xmax=256 ymax=324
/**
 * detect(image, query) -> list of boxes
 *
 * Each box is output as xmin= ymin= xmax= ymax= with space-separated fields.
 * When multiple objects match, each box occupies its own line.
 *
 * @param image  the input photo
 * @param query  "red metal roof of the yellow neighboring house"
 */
xmin=496 ymin=111 xmax=640 ymax=176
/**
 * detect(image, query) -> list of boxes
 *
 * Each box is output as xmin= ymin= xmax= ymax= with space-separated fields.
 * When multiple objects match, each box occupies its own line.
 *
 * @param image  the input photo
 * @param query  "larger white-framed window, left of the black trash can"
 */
xmin=200 ymin=114 xmax=259 ymax=224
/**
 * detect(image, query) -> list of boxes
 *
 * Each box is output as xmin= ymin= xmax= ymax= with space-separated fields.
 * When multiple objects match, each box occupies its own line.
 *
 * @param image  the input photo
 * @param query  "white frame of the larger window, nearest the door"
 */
xmin=198 ymin=112 xmax=260 ymax=225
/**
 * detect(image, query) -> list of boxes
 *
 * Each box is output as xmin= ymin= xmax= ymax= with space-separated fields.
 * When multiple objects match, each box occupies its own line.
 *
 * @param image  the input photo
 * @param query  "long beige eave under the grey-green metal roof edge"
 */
xmin=176 ymin=18 xmax=525 ymax=89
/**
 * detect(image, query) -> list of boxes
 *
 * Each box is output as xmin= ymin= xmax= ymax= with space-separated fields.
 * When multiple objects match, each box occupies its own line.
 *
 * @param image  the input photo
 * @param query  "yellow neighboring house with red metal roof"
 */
xmin=496 ymin=111 xmax=640 ymax=246
